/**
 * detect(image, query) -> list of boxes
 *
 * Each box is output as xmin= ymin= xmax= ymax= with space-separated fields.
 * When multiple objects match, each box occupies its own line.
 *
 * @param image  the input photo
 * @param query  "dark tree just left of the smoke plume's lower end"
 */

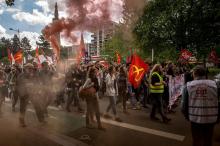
xmin=36 ymin=34 xmax=53 ymax=56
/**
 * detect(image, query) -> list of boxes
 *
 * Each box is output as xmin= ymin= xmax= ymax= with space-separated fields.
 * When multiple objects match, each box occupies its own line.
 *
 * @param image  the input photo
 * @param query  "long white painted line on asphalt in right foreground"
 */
xmin=101 ymin=118 xmax=185 ymax=141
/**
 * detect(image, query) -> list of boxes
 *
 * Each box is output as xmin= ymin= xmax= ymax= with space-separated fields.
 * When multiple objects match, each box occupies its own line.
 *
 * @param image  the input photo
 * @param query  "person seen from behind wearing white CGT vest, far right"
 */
xmin=181 ymin=66 xmax=220 ymax=146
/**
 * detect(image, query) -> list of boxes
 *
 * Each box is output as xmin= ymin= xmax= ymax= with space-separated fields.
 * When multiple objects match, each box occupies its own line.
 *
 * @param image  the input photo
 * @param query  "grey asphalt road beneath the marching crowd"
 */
xmin=0 ymin=98 xmax=220 ymax=146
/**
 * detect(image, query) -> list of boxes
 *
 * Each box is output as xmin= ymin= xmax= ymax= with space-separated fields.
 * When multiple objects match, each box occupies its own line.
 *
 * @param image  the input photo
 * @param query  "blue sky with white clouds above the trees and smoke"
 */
xmin=0 ymin=0 xmax=122 ymax=49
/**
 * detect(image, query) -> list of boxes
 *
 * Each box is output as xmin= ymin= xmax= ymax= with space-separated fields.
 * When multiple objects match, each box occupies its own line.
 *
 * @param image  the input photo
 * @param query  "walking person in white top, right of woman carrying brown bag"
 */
xmin=104 ymin=66 xmax=122 ymax=122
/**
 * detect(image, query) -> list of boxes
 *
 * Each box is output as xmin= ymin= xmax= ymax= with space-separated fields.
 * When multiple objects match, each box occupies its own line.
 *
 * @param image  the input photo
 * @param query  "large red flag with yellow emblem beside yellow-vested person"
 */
xmin=128 ymin=54 xmax=149 ymax=88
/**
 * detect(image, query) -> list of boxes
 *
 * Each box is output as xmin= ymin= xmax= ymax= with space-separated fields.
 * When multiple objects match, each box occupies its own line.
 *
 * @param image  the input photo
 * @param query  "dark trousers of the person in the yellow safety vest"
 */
xmin=150 ymin=93 xmax=165 ymax=119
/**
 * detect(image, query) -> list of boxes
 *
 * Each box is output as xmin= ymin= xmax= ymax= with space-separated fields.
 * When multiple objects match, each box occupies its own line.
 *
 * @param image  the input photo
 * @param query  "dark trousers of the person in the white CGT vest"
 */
xmin=191 ymin=123 xmax=215 ymax=146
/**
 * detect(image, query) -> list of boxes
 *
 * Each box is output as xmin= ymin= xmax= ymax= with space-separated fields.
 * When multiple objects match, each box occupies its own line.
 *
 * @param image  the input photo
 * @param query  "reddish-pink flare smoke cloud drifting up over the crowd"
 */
xmin=42 ymin=0 xmax=114 ymax=59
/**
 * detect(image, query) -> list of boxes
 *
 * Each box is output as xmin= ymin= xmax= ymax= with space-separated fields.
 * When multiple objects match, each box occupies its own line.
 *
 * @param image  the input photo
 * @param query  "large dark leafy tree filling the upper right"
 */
xmin=134 ymin=0 xmax=220 ymax=61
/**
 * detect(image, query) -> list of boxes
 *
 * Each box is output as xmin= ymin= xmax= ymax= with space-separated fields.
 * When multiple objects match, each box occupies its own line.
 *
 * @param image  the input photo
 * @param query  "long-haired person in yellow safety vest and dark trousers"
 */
xmin=149 ymin=64 xmax=171 ymax=123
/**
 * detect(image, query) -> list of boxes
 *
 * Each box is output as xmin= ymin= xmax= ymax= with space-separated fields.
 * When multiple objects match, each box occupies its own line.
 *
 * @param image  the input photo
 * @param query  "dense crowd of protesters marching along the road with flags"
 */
xmin=0 ymin=48 xmax=219 ymax=145
